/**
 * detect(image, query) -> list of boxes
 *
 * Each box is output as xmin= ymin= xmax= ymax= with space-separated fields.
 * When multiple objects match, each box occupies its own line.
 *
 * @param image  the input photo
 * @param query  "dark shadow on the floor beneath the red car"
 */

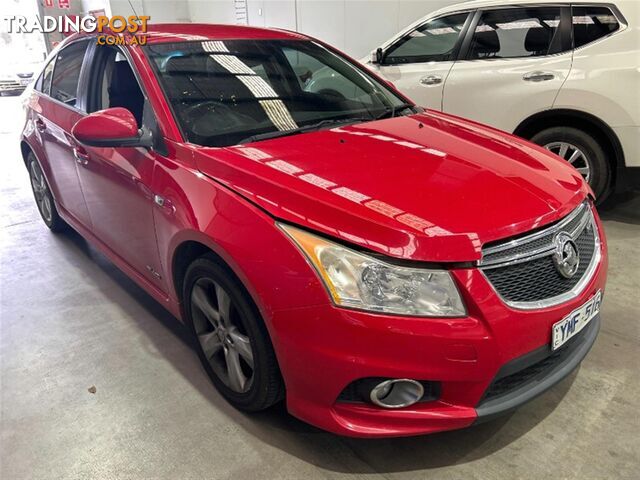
xmin=56 ymin=227 xmax=577 ymax=473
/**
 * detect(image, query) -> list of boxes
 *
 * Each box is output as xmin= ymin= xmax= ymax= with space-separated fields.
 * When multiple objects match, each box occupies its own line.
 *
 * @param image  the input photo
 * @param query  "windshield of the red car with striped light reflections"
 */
xmin=145 ymin=40 xmax=411 ymax=147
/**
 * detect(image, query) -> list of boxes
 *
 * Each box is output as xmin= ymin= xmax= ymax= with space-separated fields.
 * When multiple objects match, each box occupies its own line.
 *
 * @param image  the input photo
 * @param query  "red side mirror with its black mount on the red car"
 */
xmin=71 ymin=107 xmax=153 ymax=148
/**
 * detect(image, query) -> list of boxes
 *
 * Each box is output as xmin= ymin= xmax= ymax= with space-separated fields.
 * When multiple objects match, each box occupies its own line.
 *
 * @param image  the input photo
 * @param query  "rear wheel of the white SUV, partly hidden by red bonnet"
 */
xmin=531 ymin=127 xmax=611 ymax=203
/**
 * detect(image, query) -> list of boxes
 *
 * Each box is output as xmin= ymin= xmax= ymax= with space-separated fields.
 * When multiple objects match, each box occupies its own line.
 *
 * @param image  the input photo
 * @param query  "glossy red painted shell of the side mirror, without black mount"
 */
xmin=71 ymin=107 xmax=138 ymax=143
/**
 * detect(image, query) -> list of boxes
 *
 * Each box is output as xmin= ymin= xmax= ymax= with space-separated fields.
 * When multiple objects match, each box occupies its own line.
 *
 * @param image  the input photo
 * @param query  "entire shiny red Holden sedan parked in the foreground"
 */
xmin=21 ymin=25 xmax=607 ymax=437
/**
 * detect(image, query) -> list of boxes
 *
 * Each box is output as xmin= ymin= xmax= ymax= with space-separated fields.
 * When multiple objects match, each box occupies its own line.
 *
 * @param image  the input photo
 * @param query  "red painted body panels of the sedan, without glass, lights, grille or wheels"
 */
xmin=23 ymin=25 xmax=607 ymax=436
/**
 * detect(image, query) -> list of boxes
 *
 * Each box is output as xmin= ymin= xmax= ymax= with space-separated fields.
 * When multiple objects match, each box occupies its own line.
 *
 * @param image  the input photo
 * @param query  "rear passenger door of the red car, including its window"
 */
xmin=34 ymin=40 xmax=91 ymax=228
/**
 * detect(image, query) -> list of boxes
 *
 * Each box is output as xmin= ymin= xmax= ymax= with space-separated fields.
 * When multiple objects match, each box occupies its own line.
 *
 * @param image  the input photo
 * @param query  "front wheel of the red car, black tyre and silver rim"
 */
xmin=182 ymin=255 xmax=284 ymax=411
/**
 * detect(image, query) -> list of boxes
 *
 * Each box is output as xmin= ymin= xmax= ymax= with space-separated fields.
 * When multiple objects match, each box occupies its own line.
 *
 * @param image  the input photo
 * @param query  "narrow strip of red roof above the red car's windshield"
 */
xmin=137 ymin=23 xmax=308 ymax=44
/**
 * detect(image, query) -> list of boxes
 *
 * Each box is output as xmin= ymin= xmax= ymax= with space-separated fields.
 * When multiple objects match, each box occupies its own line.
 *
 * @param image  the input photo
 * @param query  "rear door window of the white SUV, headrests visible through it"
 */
xmin=468 ymin=7 xmax=562 ymax=60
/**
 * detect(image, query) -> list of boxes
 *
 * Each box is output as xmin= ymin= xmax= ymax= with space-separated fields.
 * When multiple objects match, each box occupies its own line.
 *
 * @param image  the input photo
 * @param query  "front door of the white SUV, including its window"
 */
xmin=370 ymin=12 xmax=471 ymax=110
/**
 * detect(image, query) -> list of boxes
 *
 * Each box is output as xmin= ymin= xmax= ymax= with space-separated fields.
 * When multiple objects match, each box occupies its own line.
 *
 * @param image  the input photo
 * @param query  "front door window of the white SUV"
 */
xmin=384 ymin=13 xmax=469 ymax=65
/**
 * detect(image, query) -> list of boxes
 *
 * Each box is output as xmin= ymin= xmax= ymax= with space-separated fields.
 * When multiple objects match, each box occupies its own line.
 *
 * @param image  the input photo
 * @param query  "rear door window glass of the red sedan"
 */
xmin=47 ymin=42 xmax=89 ymax=107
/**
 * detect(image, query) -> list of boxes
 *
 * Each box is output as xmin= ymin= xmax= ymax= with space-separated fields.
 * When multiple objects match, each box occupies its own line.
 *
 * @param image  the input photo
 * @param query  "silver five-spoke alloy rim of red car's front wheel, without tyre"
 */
xmin=191 ymin=278 xmax=254 ymax=393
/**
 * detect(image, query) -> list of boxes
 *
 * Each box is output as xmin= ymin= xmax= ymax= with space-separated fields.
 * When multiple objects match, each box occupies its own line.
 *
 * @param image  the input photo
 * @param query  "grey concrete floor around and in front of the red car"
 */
xmin=0 ymin=94 xmax=640 ymax=480
